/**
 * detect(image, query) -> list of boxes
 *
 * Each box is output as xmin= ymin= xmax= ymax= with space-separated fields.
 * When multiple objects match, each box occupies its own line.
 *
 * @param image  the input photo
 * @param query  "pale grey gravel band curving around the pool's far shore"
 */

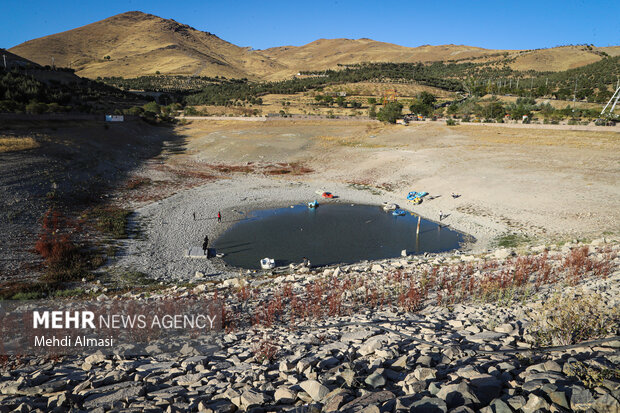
xmin=114 ymin=176 xmax=508 ymax=281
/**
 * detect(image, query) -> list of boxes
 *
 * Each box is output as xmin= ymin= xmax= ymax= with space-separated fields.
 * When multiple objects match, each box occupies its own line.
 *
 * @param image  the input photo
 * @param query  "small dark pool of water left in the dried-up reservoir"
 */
xmin=213 ymin=203 xmax=467 ymax=269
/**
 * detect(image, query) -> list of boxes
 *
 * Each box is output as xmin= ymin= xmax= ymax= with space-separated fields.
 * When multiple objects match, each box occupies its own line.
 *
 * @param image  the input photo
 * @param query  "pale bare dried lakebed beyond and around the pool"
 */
xmin=111 ymin=120 xmax=620 ymax=278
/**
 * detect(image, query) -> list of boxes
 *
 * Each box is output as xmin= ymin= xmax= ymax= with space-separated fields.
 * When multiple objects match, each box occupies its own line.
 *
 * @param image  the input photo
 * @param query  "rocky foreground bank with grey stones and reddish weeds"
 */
xmin=0 ymin=239 xmax=620 ymax=413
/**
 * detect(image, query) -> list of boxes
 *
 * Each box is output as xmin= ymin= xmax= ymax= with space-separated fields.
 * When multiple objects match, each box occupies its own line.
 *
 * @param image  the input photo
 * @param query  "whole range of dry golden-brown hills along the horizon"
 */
xmin=11 ymin=11 xmax=620 ymax=80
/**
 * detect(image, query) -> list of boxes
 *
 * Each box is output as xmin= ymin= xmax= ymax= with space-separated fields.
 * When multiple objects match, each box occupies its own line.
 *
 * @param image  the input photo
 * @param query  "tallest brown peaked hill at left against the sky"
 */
xmin=11 ymin=11 xmax=281 ymax=78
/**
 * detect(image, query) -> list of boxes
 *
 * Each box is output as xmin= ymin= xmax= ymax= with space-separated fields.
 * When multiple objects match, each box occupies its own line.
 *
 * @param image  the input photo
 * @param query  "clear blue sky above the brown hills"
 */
xmin=0 ymin=0 xmax=620 ymax=49
